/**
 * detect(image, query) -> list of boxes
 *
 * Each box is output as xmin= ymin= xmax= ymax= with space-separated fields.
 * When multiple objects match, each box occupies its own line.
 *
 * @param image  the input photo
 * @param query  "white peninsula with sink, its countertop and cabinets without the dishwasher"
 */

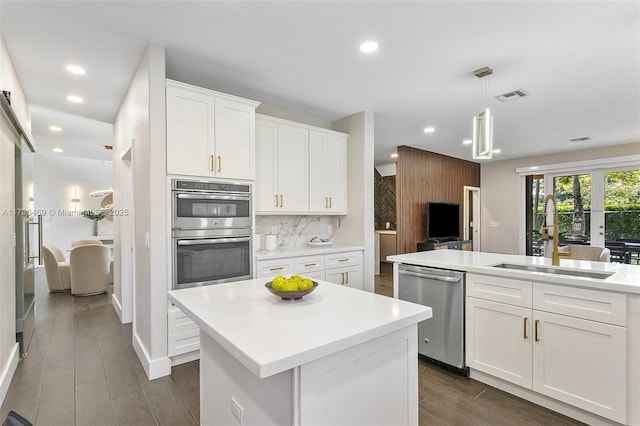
xmin=388 ymin=250 xmax=640 ymax=426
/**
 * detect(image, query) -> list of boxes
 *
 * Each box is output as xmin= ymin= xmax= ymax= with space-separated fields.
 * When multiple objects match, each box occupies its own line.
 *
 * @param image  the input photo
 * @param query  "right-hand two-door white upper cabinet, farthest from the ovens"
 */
xmin=309 ymin=130 xmax=347 ymax=214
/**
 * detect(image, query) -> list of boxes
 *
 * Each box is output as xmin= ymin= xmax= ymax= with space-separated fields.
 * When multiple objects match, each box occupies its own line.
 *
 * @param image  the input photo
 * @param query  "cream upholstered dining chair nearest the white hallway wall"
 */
xmin=69 ymin=244 xmax=111 ymax=296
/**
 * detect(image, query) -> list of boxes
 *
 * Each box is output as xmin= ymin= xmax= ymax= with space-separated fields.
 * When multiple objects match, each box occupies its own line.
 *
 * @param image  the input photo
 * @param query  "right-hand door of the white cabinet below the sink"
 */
xmin=533 ymin=311 xmax=627 ymax=423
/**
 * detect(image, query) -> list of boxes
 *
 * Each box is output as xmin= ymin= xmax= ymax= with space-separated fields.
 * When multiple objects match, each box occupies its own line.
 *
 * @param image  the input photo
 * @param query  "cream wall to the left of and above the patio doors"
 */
xmin=480 ymin=143 xmax=640 ymax=254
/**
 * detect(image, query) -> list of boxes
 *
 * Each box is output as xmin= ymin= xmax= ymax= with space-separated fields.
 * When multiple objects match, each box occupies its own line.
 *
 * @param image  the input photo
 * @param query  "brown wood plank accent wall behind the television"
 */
xmin=396 ymin=145 xmax=480 ymax=254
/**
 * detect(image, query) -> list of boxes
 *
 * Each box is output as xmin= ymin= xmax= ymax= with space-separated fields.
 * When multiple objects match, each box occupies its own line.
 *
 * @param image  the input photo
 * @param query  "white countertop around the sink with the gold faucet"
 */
xmin=387 ymin=250 xmax=640 ymax=294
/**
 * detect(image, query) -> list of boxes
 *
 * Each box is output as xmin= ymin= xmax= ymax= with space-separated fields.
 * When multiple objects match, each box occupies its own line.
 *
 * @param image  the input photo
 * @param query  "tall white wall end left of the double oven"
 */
xmin=114 ymin=45 xmax=171 ymax=379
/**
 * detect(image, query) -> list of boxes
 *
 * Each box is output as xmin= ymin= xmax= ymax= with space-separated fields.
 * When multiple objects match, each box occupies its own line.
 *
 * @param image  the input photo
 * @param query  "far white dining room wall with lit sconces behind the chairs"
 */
xmin=33 ymin=154 xmax=113 ymax=258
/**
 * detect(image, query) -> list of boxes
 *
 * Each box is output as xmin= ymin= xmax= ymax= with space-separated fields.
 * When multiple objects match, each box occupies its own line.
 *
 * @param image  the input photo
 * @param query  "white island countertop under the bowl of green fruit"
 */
xmin=169 ymin=279 xmax=431 ymax=378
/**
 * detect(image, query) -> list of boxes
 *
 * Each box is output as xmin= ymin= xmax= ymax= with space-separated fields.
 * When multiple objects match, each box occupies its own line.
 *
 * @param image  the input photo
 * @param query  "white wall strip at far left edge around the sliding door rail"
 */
xmin=0 ymin=36 xmax=31 ymax=403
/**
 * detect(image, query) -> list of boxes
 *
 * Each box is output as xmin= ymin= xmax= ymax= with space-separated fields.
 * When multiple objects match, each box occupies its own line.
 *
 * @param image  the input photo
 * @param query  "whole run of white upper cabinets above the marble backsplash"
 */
xmin=255 ymin=115 xmax=348 ymax=214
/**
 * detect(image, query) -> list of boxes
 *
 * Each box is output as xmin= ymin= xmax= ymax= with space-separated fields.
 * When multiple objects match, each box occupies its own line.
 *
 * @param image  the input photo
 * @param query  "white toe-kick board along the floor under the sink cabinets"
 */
xmin=469 ymin=369 xmax=620 ymax=426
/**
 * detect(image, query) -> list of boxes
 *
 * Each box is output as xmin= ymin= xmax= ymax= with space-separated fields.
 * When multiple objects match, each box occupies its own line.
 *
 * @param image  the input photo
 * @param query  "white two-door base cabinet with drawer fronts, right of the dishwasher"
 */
xmin=465 ymin=274 xmax=627 ymax=424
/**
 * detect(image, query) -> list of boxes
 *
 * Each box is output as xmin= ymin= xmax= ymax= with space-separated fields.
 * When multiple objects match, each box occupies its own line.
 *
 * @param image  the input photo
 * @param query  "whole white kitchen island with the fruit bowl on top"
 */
xmin=169 ymin=279 xmax=431 ymax=426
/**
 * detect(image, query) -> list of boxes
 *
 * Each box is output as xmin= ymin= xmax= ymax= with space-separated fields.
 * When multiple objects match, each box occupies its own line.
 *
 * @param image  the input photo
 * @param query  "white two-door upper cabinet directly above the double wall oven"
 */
xmin=167 ymin=80 xmax=259 ymax=180
